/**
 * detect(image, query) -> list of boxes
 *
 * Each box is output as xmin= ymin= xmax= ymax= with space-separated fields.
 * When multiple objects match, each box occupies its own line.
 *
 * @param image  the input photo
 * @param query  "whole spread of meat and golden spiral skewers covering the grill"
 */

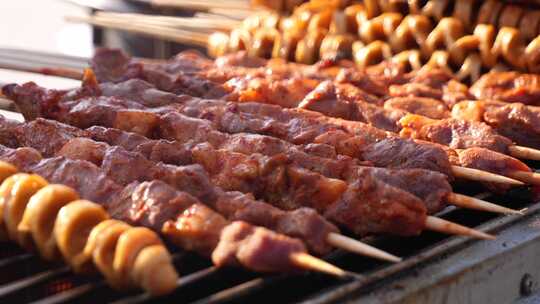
xmin=0 ymin=0 xmax=540 ymax=295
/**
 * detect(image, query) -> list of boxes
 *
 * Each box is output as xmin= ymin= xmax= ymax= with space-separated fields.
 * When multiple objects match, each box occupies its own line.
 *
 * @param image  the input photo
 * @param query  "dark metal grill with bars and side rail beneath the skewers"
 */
xmin=0 ymin=50 xmax=540 ymax=304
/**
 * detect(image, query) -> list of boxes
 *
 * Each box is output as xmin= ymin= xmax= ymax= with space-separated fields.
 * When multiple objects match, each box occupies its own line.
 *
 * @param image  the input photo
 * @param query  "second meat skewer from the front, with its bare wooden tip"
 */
xmin=0 ymin=116 xmax=399 ymax=262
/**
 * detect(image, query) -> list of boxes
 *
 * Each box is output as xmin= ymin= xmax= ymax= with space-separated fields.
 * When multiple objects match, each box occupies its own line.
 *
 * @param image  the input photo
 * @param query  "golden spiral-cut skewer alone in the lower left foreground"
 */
xmin=0 ymin=162 xmax=178 ymax=295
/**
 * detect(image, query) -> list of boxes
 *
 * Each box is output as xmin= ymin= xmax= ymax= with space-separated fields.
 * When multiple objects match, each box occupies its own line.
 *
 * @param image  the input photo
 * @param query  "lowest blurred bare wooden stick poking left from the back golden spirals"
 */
xmin=66 ymin=16 xmax=208 ymax=47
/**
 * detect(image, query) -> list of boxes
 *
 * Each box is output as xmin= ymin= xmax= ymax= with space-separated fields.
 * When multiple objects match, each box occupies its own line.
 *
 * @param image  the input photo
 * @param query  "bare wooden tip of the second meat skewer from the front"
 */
xmin=326 ymin=233 xmax=401 ymax=263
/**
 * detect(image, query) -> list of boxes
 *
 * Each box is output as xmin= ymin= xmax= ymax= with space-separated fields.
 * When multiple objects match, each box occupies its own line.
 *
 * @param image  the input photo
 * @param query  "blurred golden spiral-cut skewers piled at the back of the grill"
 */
xmin=208 ymin=0 xmax=540 ymax=81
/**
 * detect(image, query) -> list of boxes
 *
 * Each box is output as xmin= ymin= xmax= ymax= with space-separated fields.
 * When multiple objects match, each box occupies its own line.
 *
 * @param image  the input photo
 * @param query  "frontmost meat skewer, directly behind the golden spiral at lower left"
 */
xmin=0 ymin=146 xmax=348 ymax=277
